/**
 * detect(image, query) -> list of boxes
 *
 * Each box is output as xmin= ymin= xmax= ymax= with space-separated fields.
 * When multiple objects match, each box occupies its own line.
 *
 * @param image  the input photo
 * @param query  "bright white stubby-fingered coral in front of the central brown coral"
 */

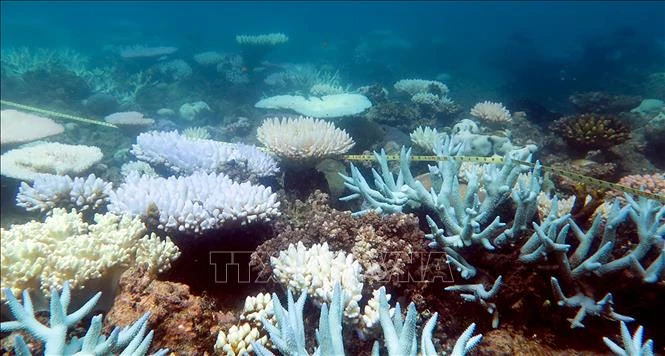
xmin=270 ymin=242 xmax=364 ymax=321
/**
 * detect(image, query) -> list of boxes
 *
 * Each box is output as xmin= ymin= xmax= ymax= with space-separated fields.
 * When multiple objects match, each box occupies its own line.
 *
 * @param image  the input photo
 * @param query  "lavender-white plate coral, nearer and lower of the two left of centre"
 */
xmin=108 ymin=172 xmax=279 ymax=233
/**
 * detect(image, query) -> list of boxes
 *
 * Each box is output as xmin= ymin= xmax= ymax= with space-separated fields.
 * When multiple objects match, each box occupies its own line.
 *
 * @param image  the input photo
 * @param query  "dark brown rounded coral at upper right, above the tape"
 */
xmin=550 ymin=114 xmax=630 ymax=151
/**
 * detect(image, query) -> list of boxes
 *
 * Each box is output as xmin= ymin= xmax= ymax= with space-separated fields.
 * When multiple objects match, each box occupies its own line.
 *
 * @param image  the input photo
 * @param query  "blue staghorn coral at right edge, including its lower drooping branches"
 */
xmin=519 ymin=194 xmax=665 ymax=328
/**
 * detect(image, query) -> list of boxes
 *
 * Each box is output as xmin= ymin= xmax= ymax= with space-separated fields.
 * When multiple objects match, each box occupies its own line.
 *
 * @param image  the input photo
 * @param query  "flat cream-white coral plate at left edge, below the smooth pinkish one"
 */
xmin=0 ymin=142 xmax=103 ymax=181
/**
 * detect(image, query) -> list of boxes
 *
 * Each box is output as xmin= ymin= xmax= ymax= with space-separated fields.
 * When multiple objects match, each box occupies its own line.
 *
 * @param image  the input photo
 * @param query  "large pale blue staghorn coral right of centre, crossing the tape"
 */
xmin=341 ymin=135 xmax=540 ymax=278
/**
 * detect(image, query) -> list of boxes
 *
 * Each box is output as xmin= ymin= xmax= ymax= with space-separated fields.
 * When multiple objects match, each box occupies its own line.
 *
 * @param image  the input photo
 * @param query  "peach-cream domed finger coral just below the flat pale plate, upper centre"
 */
xmin=257 ymin=116 xmax=355 ymax=161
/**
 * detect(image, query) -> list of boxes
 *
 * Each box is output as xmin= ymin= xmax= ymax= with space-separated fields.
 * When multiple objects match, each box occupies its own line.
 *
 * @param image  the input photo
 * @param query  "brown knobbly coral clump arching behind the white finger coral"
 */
xmin=252 ymin=191 xmax=430 ymax=291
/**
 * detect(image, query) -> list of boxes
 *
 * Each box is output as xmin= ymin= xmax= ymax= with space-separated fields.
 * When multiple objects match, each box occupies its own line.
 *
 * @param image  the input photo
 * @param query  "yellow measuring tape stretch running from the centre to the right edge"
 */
xmin=342 ymin=155 xmax=665 ymax=203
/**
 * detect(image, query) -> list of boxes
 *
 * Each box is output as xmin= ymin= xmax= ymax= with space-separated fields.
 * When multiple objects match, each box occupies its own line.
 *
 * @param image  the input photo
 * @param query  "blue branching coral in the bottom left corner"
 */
xmin=0 ymin=282 xmax=168 ymax=356
